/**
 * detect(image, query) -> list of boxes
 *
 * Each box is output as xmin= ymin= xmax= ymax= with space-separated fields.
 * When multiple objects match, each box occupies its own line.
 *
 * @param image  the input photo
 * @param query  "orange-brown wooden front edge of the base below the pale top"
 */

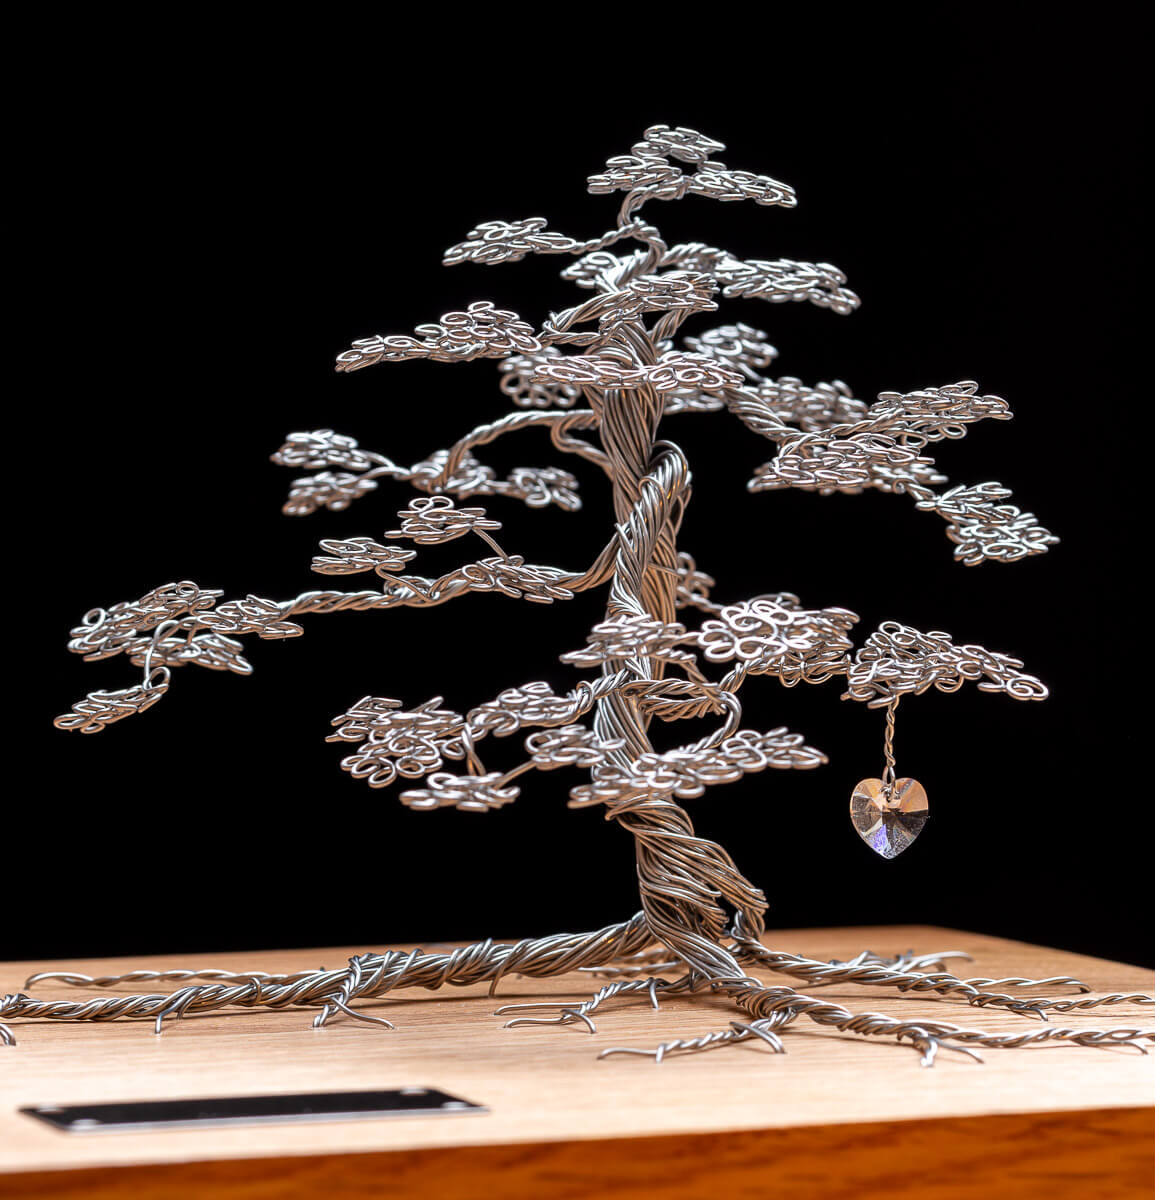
xmin=2 ymin=1109 xmax=1155 ymax=1200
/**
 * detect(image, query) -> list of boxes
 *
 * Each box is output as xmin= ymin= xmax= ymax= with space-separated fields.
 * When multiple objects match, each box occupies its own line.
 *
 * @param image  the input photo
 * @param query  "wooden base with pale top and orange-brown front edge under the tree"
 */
xmin=0 ymin=926 xmax=1155 ymax=1200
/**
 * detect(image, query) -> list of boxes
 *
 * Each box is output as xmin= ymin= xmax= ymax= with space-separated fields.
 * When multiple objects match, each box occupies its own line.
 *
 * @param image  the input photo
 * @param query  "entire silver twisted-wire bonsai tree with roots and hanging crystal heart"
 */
xmin=0 ymin=125 xmax=1155 ymax=1064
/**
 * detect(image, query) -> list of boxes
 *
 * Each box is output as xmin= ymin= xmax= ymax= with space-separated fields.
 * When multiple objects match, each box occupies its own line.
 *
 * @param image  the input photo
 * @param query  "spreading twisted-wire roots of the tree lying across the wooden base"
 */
xmin=0 ymin=914 xmax=1155 ymax=1066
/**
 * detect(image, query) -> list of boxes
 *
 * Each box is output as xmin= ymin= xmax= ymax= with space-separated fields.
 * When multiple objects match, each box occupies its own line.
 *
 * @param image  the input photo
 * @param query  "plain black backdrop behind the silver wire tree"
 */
xmin=13 ymin=18 xmax=1155 ymax=965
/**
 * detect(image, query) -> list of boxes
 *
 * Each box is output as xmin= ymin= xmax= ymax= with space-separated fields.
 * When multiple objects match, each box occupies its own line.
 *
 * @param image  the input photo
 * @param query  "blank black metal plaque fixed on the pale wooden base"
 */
xmin=20 ymin=1087 xmax=489 ymax=1133
